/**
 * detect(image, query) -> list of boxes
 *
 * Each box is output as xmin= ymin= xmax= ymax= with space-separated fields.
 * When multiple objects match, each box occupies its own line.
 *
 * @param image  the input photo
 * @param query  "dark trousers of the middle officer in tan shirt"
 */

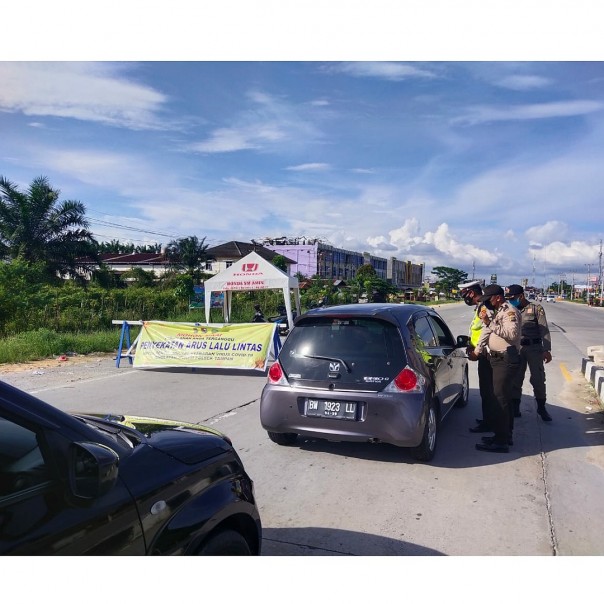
xmin=489 ymin=353 xmax=519 ymax=445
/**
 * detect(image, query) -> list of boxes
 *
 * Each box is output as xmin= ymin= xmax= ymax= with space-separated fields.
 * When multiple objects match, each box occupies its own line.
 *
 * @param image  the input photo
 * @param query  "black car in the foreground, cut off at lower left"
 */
xmin=0 ymin=381 xmax=262 ymax=556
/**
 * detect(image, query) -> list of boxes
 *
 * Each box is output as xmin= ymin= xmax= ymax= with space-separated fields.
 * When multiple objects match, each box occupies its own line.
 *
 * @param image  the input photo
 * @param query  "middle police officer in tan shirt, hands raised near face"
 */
xmin=475 ymin=284 xmax=522 ymax=453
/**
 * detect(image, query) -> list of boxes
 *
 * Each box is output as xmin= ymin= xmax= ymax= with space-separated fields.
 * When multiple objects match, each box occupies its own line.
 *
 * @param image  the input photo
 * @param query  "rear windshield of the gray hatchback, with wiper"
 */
xmin=279 ymin=317 xmax=406 ymax=389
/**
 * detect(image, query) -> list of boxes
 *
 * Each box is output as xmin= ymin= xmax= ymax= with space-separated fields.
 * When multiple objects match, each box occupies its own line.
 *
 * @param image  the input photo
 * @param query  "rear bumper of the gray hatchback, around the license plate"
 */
xmin=260 ymin=385 xmax=426 ymax=447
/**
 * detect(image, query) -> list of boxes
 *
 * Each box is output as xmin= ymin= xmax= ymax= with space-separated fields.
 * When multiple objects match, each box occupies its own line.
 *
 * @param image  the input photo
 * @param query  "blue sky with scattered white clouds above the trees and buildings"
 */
xmin=0 ymin=3 xmax=604 ymax=286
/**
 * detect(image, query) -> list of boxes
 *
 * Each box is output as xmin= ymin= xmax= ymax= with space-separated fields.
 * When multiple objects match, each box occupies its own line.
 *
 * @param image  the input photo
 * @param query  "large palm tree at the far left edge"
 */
xmin=0 ymin=176 xmax=97 ymax=279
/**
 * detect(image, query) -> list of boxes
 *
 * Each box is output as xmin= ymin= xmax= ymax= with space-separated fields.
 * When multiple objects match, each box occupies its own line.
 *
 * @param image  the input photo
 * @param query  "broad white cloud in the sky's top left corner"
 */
xmin=0 ymin=62 xmax=167 ymax=129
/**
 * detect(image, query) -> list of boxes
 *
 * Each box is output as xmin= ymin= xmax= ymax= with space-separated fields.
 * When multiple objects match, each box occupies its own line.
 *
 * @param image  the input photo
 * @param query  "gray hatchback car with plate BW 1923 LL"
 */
xmin=260 ymin=304 xmax=469 ymax=461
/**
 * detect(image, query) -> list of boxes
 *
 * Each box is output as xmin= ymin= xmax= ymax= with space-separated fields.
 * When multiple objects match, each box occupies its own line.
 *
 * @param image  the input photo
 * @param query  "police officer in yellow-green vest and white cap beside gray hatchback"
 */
xmin=457 ymin=281 xmax=494 ymax=432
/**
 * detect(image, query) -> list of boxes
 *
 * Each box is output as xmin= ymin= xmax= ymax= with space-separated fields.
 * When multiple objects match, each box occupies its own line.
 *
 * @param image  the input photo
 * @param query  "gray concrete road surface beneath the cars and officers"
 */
xmin=0 ymin=302 xmax=604 ymax=556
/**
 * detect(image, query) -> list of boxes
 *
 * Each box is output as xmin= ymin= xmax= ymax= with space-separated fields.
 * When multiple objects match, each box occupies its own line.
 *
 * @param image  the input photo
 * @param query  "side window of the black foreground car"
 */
xmin=0 ymin=417 xmax=49 ymax=501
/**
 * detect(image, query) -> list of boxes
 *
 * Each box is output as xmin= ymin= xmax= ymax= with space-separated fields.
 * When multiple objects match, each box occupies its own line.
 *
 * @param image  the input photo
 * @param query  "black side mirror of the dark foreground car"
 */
xmin=69 ymin=442 xmax=119 ymax=499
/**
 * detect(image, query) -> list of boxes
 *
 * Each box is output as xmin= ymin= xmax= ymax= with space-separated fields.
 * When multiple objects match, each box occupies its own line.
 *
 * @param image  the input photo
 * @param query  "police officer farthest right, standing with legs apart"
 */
xmin=505 ymin=284 xmax=552 ymax=422
